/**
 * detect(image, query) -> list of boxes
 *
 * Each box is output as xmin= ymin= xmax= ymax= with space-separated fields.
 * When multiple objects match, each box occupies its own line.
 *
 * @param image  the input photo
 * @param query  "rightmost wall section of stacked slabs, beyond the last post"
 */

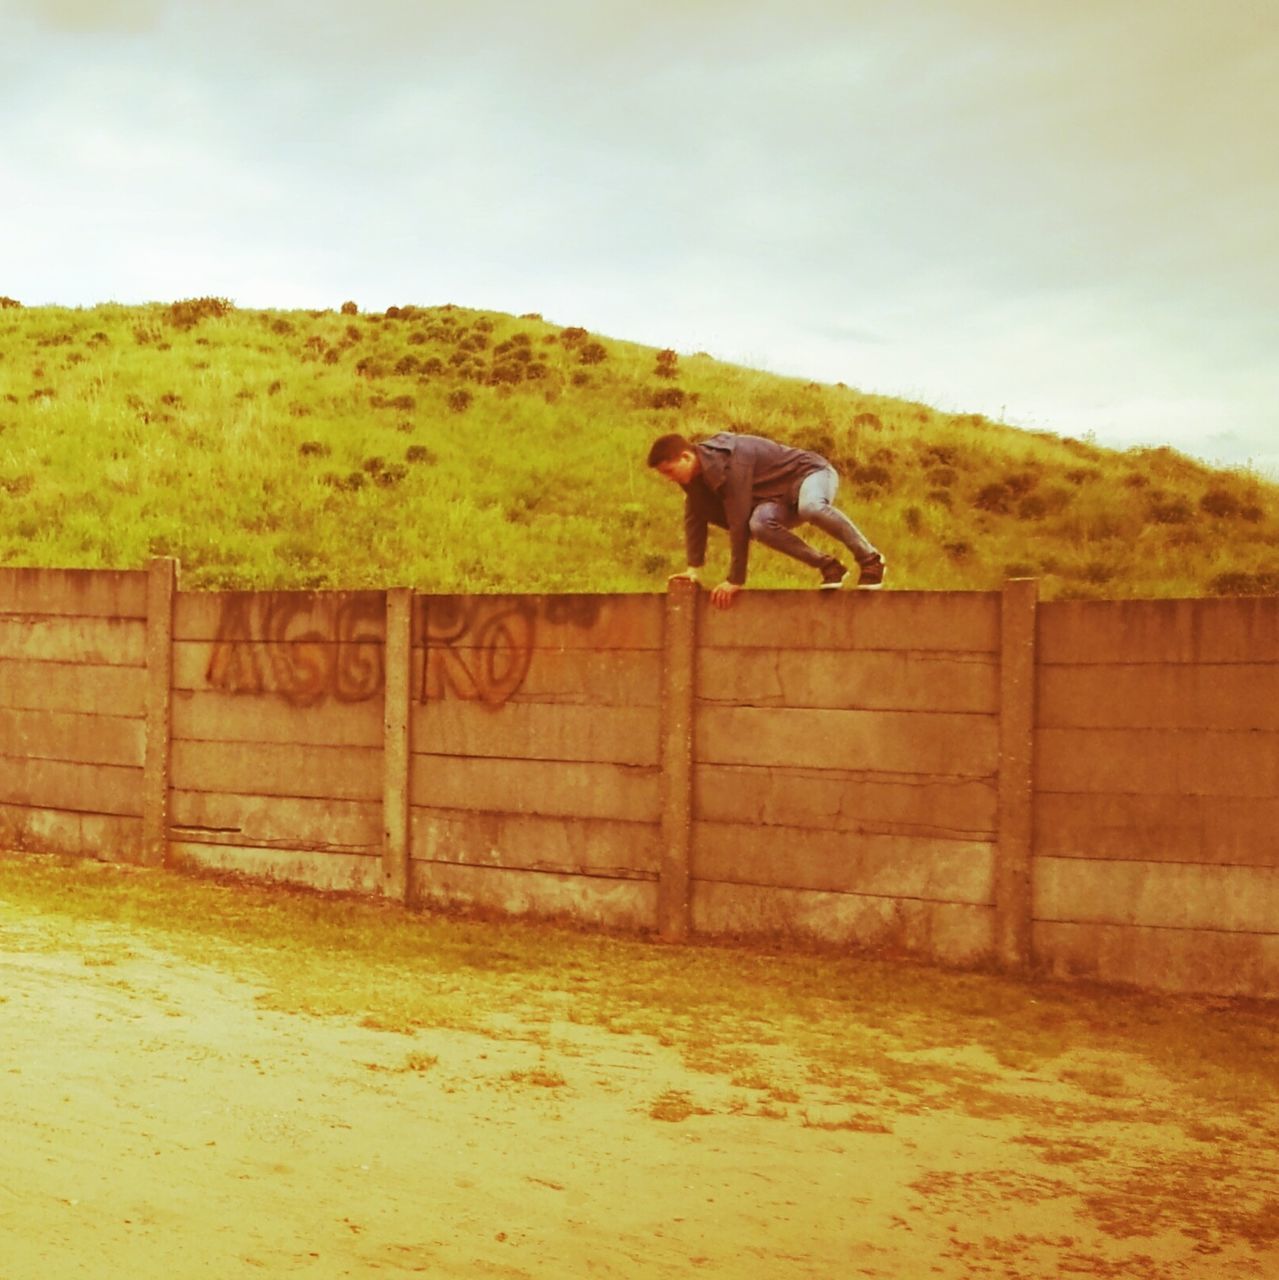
xmin=1033 ymin=599 xmax=1279 ymax=996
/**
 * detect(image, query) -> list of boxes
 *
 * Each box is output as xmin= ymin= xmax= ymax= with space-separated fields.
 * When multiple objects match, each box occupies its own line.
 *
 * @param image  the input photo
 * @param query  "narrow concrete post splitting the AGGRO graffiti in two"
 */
xmin=382 ymin=588 xmax=414 ymax=902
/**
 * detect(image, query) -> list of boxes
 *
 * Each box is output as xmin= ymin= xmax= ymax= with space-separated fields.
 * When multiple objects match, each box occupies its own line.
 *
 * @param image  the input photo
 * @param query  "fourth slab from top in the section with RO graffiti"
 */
xmin=410 ymin=755 xmax=661 ymax=823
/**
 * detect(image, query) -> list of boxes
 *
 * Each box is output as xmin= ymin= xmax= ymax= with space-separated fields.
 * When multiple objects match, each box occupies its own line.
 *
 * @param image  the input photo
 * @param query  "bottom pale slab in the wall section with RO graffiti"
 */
xmin=411 ymin=861 xmax=657 ymax=929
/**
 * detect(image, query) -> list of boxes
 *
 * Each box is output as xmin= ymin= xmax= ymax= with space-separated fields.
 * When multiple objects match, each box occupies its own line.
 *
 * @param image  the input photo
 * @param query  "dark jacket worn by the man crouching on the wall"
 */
xmin=684 ymin=431 xmax=830 ymax=586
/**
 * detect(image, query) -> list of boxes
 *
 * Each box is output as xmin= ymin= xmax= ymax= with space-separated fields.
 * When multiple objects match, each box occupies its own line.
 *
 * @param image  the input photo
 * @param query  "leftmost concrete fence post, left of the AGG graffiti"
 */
xmin=142 ymin=557 xmax=178 ymax=867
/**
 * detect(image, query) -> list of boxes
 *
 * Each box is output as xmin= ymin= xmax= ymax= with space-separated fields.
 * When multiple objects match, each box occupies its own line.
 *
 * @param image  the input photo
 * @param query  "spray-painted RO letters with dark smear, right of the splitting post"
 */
xmin=419 ymin=595 xmax=600 ymax=710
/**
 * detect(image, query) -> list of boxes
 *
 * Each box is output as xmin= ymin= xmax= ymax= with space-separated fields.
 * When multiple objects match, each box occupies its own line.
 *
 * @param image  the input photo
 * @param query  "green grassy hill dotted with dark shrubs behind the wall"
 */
xmin=0 ymin=298 xmax=1279 ymax=598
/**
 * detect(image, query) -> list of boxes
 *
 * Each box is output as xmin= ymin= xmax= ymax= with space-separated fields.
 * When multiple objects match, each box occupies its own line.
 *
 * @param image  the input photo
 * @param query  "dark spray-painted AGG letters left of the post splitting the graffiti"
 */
xmin=205 ymin=591 xmax=385 ymax=707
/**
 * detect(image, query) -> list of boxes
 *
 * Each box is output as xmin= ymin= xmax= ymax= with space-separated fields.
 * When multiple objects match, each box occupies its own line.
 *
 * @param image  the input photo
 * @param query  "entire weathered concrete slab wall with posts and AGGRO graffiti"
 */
xmin=0 ymin=562 xmax=1279 ymax=996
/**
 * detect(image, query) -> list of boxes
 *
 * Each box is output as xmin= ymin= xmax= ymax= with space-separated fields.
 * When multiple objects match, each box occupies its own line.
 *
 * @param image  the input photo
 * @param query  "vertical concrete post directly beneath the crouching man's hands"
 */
xmin=657 ymin=579 xmax=698 ymax=942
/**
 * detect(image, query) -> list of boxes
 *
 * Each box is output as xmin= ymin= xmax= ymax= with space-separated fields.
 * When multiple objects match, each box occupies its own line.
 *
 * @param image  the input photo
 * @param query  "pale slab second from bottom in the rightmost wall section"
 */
xmin=1034 ymin=858 xmax=1279 ymax=936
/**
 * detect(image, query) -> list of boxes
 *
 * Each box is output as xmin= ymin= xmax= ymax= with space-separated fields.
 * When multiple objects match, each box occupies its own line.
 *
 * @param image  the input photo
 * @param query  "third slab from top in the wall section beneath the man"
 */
xmin=694 ymin=704 xmax=999 ymax=777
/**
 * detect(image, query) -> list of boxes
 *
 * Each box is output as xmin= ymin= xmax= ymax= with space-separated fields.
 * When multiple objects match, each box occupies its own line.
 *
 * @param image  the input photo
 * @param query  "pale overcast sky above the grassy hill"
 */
xmin=0 ymin=0 xmax=1279 ymax=476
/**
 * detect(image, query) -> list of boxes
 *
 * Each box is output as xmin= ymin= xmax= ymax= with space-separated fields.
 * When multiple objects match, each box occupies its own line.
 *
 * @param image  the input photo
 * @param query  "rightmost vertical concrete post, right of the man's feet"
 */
xmin=995 ymin=577 xmax=1038 ymax=970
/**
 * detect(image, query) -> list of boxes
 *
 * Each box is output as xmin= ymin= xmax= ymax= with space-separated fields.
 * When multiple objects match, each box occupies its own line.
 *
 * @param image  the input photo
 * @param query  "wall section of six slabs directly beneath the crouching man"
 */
xmin=691 ymin=591 xmax=1000 ymax=960
